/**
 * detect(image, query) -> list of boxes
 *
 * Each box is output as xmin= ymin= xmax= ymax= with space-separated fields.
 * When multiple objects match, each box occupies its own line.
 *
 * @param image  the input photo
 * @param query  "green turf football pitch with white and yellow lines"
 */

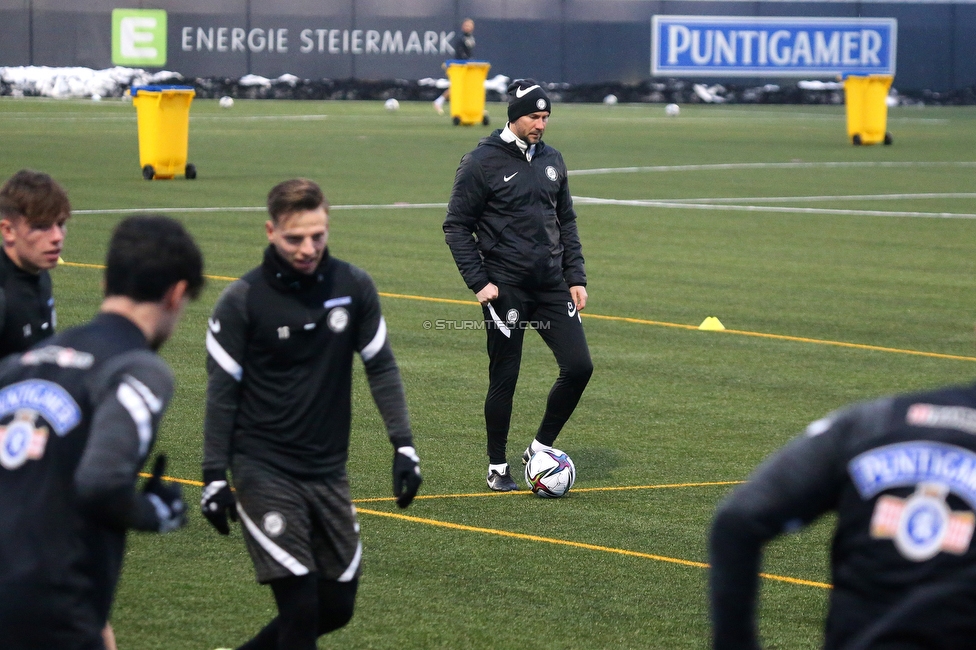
xmin=0 ymin=99 xmax=976 ymax=650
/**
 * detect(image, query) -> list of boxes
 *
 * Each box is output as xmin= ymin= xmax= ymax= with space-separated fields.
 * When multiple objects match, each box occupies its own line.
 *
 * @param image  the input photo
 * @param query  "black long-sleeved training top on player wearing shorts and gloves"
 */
xmin=203 ymin=246 xmax=413 ymax=482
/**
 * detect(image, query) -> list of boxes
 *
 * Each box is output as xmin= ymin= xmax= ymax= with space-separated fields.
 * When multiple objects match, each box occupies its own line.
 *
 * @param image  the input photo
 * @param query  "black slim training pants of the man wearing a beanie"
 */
xmin=482 ymin=284 xmax=593 ymax=464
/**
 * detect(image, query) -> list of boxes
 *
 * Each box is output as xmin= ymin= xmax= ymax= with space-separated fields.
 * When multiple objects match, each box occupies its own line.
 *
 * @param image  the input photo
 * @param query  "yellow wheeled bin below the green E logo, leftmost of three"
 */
xmin=132 ymin=86 xmax=197 ymax=181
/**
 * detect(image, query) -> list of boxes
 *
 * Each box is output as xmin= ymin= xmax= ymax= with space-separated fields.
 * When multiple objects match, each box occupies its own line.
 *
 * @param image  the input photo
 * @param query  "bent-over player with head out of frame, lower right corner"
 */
xmin=710 ymin=386 xmax=976 ymax=650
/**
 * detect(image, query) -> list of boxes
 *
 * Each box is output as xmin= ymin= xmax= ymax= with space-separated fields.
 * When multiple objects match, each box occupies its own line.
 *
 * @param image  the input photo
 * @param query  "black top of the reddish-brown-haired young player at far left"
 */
xmin=0 ymin=247 xmax=57 ymax=358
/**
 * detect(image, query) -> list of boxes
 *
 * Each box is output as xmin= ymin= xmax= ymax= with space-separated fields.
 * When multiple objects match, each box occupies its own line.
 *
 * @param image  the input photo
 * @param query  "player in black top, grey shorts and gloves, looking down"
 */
xmin=201 ymin=179 xmax=421 ymax=650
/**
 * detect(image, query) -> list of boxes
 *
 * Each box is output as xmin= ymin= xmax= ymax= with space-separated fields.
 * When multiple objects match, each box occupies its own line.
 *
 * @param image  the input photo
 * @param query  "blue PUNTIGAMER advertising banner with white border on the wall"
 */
xmin=651 ymin=16 xmax=898 ymax=77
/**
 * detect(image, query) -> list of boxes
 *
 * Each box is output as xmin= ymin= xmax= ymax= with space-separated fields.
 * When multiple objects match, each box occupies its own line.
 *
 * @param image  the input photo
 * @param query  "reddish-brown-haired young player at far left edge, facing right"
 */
xmin=0 ymin=169 xmax=71 ymax=358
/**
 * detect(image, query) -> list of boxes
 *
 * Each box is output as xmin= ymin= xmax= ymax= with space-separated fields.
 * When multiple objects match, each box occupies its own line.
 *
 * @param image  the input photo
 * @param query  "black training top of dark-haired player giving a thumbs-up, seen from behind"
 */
xmin=0 ymin=314 xmax=173 ymax=647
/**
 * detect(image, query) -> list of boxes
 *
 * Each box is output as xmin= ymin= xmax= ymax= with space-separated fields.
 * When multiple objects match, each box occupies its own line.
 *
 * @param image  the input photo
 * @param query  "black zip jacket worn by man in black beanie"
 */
xmin=444 ymin=129 xmax=586 ymax=293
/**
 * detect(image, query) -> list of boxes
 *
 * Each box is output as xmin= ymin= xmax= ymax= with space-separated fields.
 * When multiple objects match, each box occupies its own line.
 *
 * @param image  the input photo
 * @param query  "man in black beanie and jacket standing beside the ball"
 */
xmin=444 ymin=79 xmax=593 ymax=491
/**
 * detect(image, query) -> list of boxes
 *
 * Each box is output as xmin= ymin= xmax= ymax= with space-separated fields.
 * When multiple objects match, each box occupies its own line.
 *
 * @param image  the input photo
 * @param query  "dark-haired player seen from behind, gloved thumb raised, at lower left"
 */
xmin=0 ymin=216 xmax=203 ymax=650
